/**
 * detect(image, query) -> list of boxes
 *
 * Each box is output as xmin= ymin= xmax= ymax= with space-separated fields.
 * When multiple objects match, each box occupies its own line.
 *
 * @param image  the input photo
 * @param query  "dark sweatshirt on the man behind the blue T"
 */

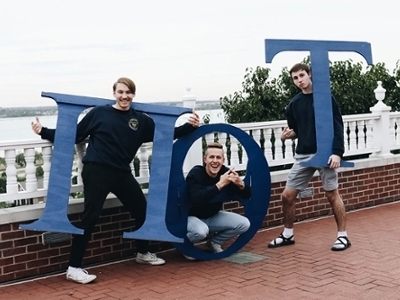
xmin=286 ymin=93 xmax=344 ymax=157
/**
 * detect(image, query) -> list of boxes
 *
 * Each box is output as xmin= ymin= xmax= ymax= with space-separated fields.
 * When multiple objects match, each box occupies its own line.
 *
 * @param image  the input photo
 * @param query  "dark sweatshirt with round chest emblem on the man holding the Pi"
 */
xmin=40 ymin=105 xmax=196 ymax=172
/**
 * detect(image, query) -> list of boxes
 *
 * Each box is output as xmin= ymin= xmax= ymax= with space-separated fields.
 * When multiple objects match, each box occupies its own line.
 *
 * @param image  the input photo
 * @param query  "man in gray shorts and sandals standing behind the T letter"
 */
xmin=268 ymin=64 xmax=351 ymax=251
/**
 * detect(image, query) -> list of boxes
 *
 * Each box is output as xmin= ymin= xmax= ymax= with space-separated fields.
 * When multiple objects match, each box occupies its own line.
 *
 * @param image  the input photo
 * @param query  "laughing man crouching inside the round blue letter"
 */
xmin=185 ymin=143 xmax=251 ymax=259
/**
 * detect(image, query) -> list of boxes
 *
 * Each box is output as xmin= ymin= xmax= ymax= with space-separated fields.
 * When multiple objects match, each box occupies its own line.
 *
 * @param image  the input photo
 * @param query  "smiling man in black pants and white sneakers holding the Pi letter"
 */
xmin=32 ymin=77 xmax=199 ymax=284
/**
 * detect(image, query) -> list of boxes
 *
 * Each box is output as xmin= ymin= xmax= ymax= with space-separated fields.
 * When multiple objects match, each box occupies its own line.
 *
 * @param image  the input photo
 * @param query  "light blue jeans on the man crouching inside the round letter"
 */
xmin=186 ymin=210 xmax=250 ymax=245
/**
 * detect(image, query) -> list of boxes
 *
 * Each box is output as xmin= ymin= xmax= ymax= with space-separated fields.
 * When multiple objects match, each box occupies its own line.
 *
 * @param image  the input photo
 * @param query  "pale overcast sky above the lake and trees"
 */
xmin=0 ymin=0 xmax=400 ymax=106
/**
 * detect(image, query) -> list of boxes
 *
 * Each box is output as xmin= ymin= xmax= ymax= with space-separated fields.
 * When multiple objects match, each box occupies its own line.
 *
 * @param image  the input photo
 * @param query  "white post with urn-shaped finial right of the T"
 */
xmin=370 ymin=81 xmax=392 ymax=158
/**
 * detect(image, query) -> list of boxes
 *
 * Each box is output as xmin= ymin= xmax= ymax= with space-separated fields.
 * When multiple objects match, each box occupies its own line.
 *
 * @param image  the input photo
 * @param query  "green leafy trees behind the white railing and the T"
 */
xmin=220 ymin=57 xmax=400 ymax=123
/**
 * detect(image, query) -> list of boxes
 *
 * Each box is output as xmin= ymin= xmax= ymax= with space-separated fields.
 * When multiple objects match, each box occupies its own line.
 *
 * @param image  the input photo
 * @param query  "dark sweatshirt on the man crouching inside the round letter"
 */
xmin=186 ymin=166 xmax=251 ymax=219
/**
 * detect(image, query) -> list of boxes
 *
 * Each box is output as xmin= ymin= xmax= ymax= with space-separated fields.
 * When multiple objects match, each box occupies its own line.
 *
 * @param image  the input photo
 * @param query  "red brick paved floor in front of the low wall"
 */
xmin=0 ymin=203 xmax=400 ymax=300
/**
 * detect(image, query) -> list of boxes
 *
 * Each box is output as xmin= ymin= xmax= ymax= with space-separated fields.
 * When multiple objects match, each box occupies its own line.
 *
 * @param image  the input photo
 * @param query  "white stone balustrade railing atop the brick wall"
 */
xmin=0 ymin=112 xmax=400 ymax=204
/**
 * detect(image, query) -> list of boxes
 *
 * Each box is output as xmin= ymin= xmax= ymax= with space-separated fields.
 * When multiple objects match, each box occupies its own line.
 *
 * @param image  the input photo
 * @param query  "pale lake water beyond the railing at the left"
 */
xmin=0 ymin=109 xmax=225 ymax=143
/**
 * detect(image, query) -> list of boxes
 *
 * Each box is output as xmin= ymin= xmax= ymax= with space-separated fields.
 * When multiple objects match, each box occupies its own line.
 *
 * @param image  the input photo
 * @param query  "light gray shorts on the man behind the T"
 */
xmin=286 ymin=154 xmax=338 ymax=191
